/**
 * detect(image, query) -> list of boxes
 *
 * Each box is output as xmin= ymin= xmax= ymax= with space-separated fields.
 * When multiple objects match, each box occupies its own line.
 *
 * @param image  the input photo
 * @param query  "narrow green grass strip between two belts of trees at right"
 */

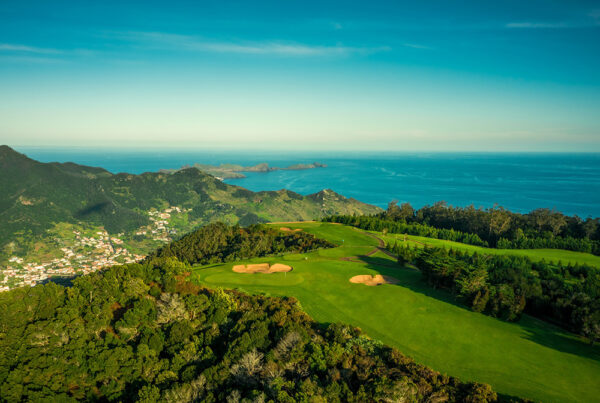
xmin=380 ymin=231 xmax=600 ymax=267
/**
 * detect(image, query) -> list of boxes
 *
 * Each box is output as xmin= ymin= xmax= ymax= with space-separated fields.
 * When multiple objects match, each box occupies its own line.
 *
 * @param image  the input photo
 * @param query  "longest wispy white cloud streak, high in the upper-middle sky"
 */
xmin=116 ymin=32 xmax=390 ymax=56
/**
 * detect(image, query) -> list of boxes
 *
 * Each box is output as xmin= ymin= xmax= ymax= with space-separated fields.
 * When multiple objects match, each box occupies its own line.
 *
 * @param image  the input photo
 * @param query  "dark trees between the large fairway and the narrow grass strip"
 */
xmin=388 ymin=243 xmax=600 ymax=343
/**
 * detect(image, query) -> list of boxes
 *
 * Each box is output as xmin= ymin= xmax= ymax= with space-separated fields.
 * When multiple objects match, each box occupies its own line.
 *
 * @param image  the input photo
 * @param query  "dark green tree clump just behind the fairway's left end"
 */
xmin=147 ymin=223 xmax=335 ymax=264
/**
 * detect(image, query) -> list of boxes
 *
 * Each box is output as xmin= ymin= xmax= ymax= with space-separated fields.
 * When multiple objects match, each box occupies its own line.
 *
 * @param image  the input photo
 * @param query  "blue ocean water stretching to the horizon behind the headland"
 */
xmin=17 ymin=147 xmax=600 ymax=217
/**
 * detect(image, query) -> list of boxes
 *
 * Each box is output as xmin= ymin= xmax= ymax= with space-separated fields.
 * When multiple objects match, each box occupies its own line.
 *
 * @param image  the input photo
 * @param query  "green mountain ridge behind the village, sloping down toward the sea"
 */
xmin=0 ymin=146 xmax=380 ymax=270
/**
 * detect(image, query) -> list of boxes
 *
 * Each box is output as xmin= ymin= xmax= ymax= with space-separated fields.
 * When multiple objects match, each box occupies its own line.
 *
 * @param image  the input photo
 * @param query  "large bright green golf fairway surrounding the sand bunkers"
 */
xmin=194 ymin=223 xmax=600 ymax=402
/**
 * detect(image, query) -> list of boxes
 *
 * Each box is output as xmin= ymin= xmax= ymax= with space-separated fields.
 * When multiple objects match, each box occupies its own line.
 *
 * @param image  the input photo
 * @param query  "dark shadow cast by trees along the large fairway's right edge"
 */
xmin=360 ymin=256 xmax=600 ymax=361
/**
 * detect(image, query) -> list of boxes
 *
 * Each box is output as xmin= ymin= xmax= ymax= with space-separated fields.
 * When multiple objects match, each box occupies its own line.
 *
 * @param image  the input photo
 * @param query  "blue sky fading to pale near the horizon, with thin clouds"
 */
xmin=0 ymin=0 xmax=600 ymax=152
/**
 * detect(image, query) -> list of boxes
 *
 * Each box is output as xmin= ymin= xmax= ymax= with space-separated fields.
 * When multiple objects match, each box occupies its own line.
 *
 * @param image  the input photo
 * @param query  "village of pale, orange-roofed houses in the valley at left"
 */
xmin=0 ymin=206 xmax=187 ymax=292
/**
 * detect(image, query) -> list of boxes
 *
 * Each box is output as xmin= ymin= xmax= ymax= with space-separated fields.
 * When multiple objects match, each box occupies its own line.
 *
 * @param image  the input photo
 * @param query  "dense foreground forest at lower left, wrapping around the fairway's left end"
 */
xmin=0 ymin=225 xmax=502 ymax=402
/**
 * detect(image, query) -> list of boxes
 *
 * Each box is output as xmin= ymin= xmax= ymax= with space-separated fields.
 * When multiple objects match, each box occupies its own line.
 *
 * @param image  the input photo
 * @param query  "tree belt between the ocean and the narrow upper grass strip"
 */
xmin=323 ymin=202 xmax=600 ymax=255
